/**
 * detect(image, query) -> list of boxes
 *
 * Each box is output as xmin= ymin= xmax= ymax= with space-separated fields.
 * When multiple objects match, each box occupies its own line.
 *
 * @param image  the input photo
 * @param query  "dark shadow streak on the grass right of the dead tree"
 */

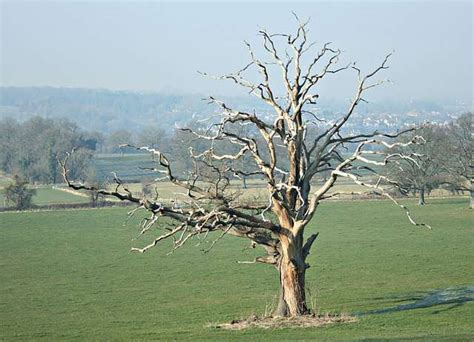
xmin=355 ymin=286 xmax=474 ymax=316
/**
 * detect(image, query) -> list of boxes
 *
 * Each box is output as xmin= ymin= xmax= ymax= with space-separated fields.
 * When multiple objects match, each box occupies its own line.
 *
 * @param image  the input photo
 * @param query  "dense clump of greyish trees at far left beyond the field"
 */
xmin=0 ymin=117 xmax=100 ymax=183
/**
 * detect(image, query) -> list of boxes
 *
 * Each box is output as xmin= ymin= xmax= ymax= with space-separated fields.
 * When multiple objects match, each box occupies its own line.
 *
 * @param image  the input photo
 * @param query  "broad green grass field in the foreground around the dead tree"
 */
xmin=0 ymin=198 xmax=474 ymax=341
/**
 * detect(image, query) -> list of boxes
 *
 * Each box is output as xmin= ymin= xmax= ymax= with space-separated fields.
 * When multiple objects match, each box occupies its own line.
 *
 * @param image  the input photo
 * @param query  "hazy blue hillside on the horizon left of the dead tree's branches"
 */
xmin=0 ymin=87 xmax=212 ymax=133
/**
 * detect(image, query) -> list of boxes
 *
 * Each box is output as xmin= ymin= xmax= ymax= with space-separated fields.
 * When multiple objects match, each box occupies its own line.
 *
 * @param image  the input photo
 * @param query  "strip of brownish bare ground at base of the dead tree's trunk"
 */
xmin=208 ymin=314 xmax=357 ymax=330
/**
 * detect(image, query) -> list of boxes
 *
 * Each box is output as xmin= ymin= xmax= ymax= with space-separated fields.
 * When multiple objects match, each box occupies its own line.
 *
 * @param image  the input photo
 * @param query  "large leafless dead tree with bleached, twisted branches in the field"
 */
xmin=61 ymin=20 xmax=430 ymax=316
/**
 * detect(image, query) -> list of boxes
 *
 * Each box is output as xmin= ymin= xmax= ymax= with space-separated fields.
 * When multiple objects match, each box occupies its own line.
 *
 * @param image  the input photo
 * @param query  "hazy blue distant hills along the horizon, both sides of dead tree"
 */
xmin=0 ymin=87 xmax=473 ymax=133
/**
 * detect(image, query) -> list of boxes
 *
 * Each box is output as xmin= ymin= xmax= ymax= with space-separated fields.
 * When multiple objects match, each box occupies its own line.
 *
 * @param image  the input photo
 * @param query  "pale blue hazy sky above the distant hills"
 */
xmin=0 ymin=0 xmax=473 ymax=101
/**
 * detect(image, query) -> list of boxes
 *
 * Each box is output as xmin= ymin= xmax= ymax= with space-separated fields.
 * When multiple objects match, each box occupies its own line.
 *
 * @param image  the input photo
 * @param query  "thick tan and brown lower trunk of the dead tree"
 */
xmin=274 ymin=236 xmax=309 ymax=317
